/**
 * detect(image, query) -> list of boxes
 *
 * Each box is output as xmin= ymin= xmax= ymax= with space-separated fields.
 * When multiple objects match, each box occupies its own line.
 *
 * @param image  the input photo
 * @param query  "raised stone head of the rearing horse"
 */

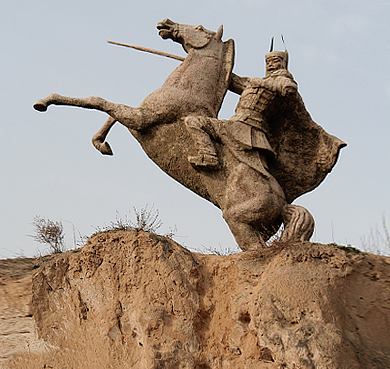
xmin=157 ymin=18 xmax=223 ymax=53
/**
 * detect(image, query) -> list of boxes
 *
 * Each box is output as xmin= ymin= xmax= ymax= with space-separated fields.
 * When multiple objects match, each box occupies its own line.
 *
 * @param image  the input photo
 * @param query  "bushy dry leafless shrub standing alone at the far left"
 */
xmin=30 ymin=215 xmax=65 ymax=254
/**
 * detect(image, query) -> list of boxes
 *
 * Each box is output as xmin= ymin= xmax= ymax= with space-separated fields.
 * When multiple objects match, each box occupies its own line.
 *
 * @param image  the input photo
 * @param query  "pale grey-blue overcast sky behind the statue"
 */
xmin=0 ymin=0 xmax=390 ymax=258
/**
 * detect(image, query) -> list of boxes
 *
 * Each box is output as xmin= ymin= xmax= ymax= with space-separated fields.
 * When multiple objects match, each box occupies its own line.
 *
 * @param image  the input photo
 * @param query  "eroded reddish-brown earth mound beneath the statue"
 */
xmin=3 ymin=231 xmax=390 ymax=369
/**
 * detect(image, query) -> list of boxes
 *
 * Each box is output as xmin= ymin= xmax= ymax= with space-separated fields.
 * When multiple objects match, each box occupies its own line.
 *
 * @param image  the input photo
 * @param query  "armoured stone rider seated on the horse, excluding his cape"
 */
xmin=185 ymin=51 xmax=297 ymax=177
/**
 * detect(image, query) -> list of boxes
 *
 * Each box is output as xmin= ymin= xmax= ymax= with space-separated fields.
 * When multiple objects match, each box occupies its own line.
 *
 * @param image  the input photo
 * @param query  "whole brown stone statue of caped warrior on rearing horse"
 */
xmin=34 ymin=19 xmax=345 ymax=251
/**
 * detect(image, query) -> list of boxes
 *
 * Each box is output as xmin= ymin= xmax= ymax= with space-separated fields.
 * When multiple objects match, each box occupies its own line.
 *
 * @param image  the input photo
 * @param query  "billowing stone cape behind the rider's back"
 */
xmin=269 ymin=93 xmax=347 ymax=203
